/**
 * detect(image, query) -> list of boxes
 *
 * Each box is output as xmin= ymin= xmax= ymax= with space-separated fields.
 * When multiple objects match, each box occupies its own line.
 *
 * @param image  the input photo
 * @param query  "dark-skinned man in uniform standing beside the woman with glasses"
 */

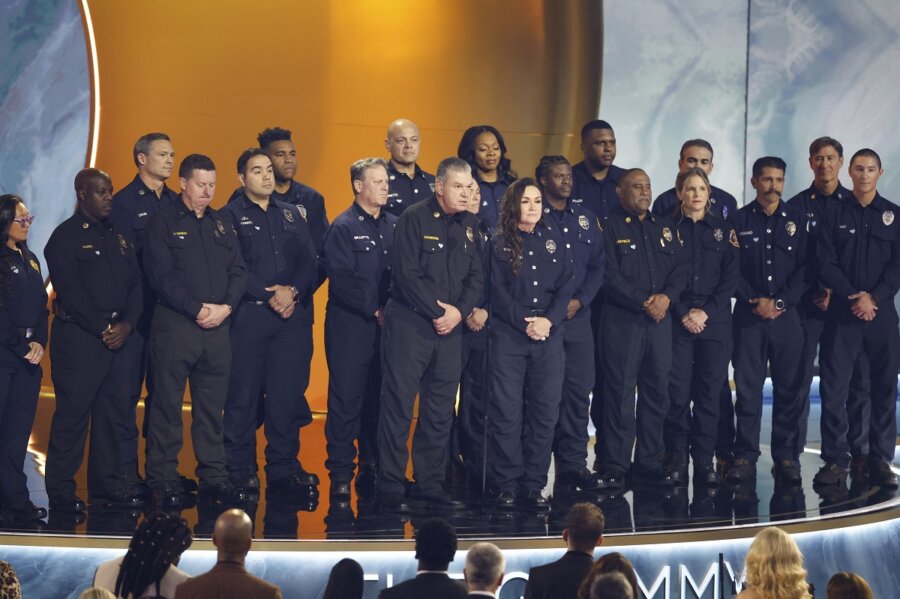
xmin=44 ymin=168 xmax=143 ymax=512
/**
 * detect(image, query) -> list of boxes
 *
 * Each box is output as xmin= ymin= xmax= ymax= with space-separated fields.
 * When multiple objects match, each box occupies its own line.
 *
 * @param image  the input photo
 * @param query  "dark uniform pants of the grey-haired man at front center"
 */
xmin=378 ymin=300 xmax=465 ymax=493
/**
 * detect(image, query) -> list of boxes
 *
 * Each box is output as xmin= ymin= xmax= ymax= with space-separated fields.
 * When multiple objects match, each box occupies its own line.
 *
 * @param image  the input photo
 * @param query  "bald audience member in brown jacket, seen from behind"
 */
xmin=175 ymin=509 xmax=281 ymax=599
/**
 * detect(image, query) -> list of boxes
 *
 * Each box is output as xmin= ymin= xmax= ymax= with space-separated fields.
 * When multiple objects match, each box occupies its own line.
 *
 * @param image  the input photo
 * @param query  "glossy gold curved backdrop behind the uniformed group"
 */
xmin=63 ymin=0 xmax=602 ymax=409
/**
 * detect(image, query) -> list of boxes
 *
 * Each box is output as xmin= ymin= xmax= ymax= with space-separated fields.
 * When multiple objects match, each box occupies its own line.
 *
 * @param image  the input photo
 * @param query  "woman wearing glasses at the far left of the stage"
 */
xmin=0 ymin=194 xmax=48 ymax=523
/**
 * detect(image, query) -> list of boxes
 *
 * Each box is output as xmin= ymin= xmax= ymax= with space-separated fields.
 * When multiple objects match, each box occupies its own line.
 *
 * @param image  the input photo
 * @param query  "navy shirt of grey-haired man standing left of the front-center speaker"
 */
xmin=323 ymin=202 xmax=397 ymax=320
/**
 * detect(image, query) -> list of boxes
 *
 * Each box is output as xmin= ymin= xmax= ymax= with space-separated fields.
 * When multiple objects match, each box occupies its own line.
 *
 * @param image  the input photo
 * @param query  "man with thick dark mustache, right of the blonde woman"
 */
xmin=725 ymin=156 xmax=808 ymax=485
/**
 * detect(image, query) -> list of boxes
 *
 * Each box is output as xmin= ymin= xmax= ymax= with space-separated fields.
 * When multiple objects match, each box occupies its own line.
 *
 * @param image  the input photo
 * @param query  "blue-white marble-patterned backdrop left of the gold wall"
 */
xmin=0 ymin=0 xmax=90 ymax=262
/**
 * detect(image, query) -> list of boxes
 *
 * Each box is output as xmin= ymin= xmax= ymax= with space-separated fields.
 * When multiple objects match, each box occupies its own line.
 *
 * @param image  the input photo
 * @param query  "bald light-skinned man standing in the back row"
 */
xmin=384 ymin=119 xmax=434 ymax=216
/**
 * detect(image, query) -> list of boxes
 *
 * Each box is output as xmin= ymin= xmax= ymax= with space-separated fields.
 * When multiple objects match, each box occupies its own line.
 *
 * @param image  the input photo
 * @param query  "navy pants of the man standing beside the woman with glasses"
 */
xmin=46 ymin=318 xmax=127 ymax=497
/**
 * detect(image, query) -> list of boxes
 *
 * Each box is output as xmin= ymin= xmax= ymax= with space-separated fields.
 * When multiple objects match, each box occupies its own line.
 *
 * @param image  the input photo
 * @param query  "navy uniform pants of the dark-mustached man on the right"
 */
xmin=733 ymin=304 xmax=805 ymax=463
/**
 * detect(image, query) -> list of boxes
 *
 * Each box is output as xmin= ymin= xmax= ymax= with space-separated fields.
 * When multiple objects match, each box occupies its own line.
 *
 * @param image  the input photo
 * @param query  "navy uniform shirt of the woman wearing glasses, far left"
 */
xmin=0 ymin=244 xmax=48 ymax=358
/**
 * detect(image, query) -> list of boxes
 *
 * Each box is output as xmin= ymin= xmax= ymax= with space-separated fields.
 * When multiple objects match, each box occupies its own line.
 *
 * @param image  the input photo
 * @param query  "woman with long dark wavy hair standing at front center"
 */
xmin=487 ymin=178 xmax=574 ymax=511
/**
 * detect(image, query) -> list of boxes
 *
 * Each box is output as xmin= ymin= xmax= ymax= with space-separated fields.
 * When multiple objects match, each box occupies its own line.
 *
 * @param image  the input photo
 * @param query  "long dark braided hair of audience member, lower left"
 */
xmin=115 ymin=512 xmax=193 ymax=598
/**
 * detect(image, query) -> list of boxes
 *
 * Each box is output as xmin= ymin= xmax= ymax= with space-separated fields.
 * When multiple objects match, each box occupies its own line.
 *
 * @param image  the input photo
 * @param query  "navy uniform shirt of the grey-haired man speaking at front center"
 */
xmin=391 ymin=196 xmax=484 ymax=328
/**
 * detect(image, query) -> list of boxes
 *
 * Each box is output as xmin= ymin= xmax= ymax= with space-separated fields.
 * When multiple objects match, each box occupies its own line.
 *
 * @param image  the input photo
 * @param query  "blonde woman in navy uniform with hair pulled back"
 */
xmin=663 ymin=168 xmax=740 ymax=485
